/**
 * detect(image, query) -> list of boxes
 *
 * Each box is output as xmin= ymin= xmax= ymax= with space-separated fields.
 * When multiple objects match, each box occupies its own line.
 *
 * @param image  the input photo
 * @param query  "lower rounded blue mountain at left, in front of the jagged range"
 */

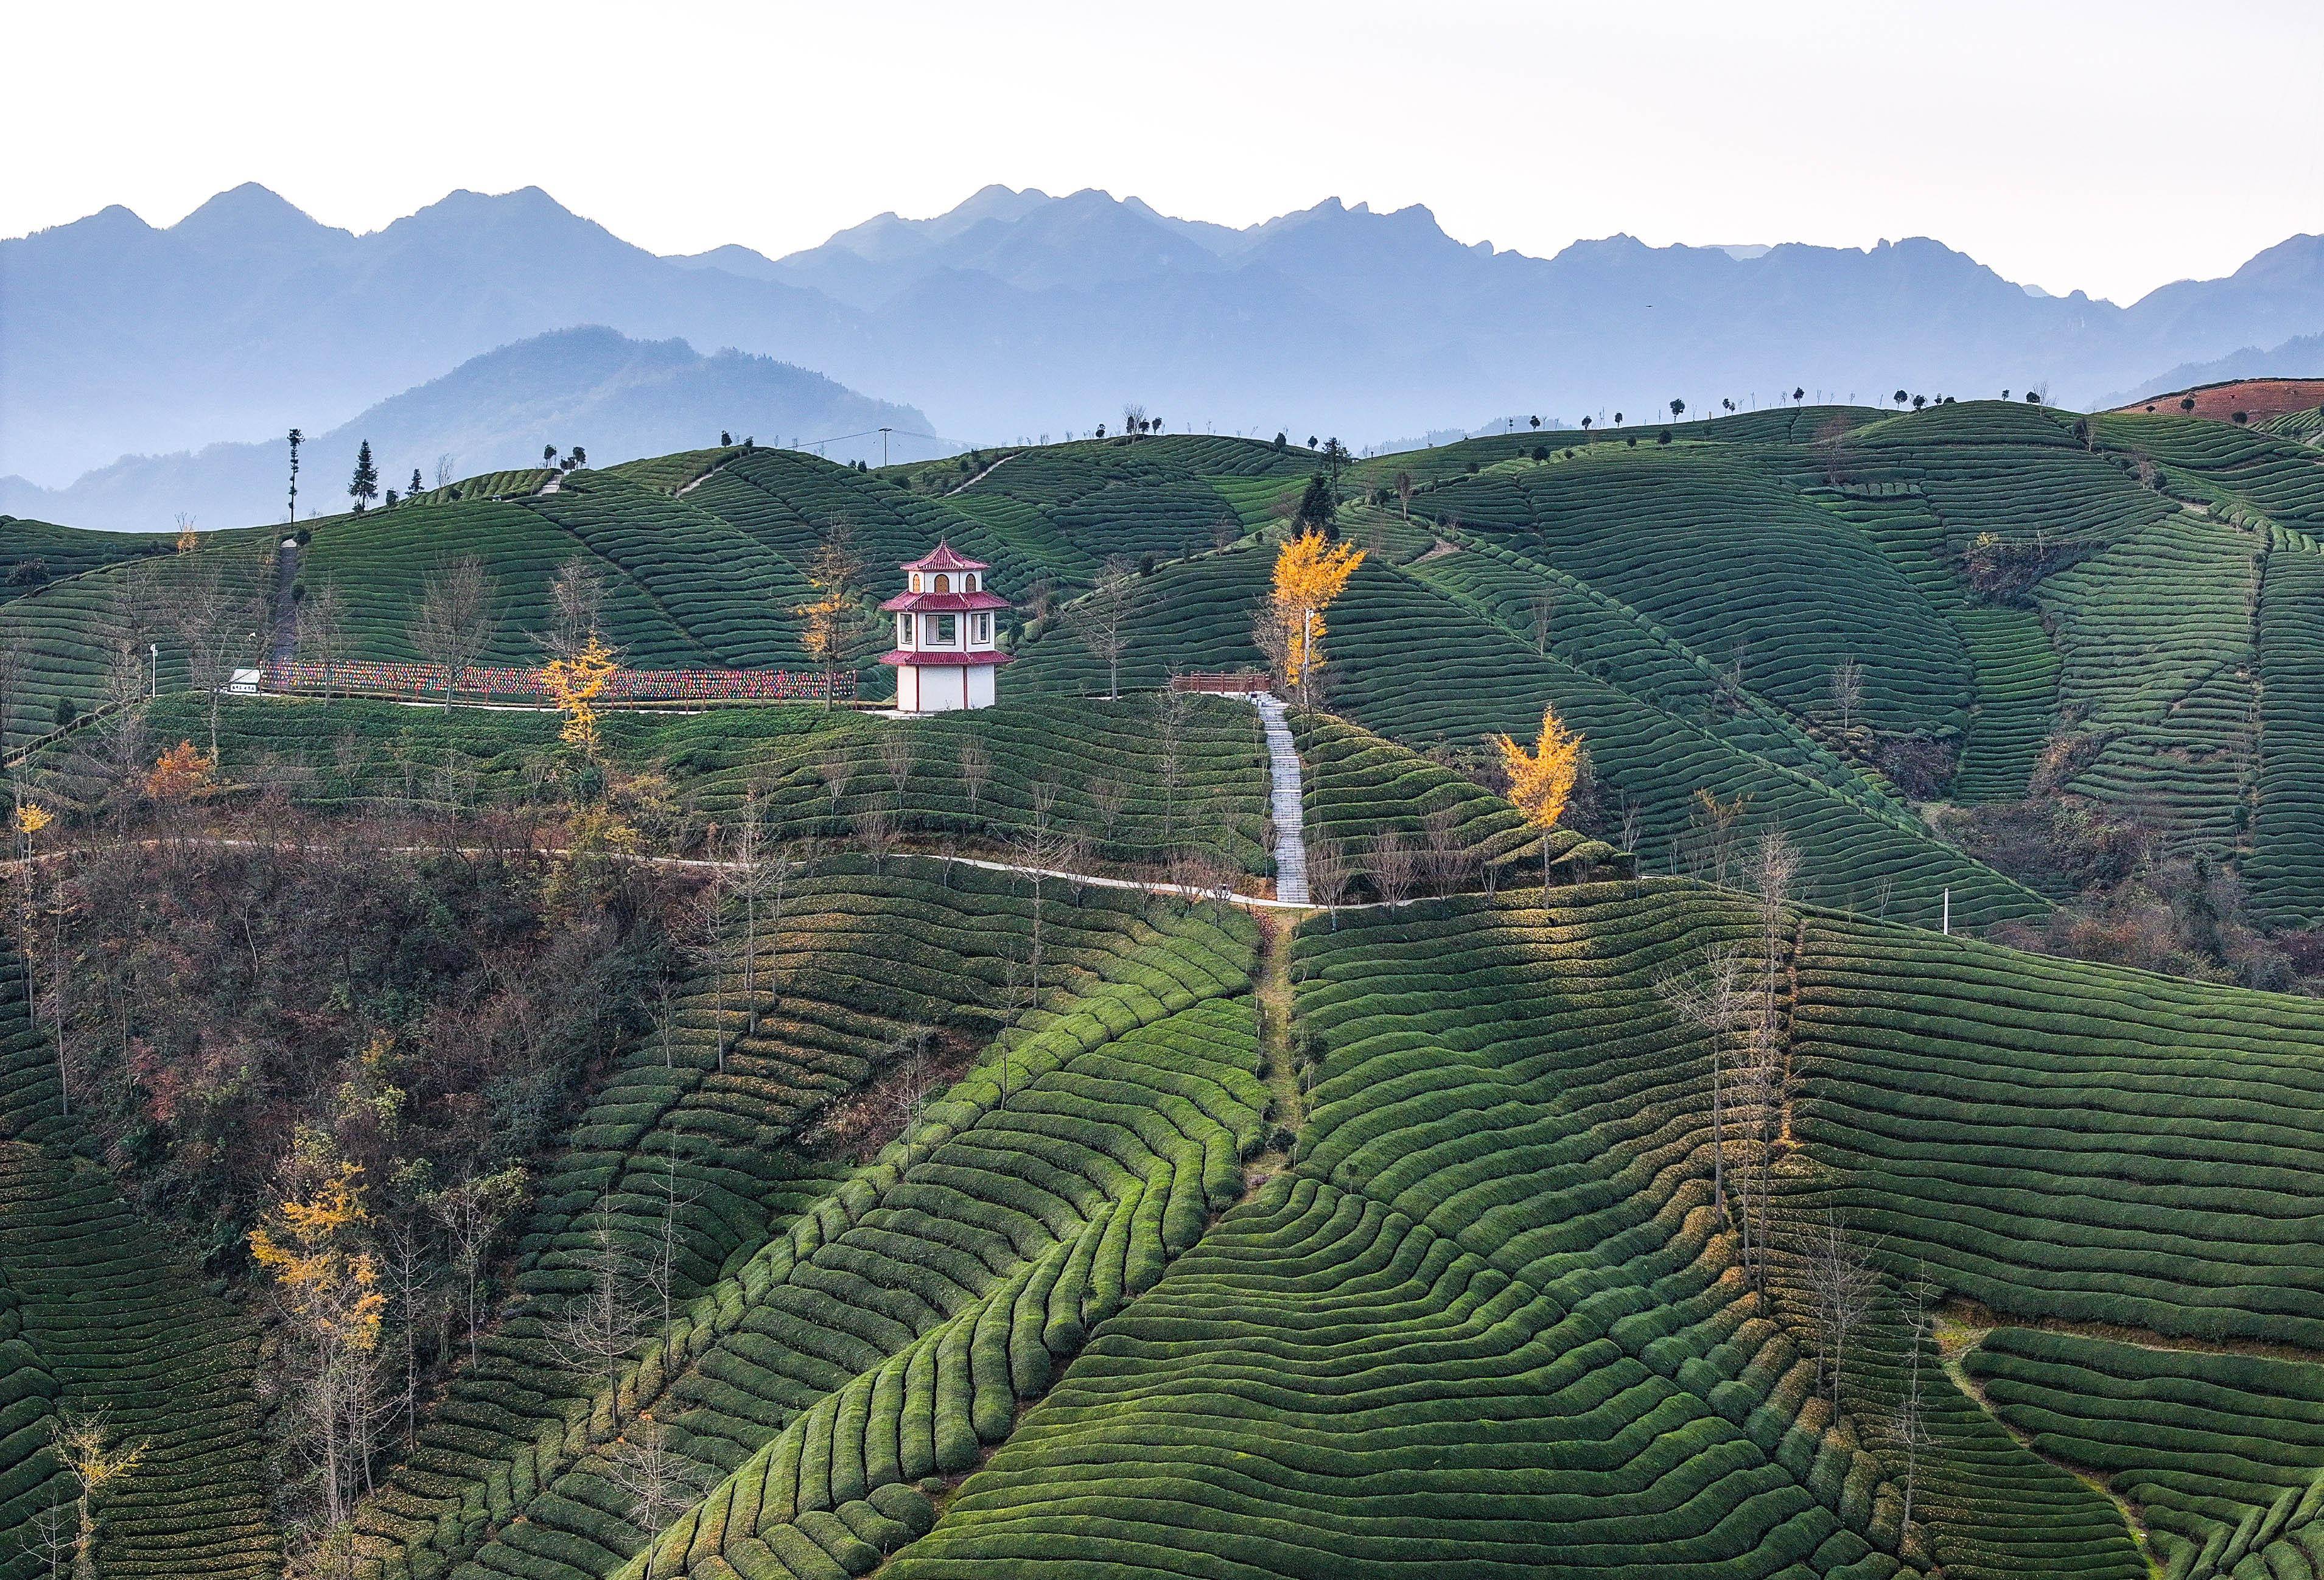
xmin=0 ymin=327 xmax=955 ymax=530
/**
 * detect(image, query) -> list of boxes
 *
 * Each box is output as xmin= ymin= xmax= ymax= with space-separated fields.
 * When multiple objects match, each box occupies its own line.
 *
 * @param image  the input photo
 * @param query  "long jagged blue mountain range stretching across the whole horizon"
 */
xmin=13 ymin=186 xmax=2324 ymax=506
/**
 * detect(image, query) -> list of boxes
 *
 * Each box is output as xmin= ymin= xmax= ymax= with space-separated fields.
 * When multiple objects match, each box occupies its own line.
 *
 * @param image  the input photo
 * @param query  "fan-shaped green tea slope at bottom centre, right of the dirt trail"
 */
xmin=892 ymin=886 xmax=1920 ymax=1580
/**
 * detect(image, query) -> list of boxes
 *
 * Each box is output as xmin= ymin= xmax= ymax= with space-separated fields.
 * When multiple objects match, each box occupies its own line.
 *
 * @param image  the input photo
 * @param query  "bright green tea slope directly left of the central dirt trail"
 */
xmin=623 ymin=999 xmax=1267 ymax=1580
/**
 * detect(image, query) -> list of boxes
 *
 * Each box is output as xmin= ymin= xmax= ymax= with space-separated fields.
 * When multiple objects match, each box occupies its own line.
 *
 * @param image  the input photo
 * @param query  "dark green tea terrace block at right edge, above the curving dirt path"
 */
xmin=1792 ymin=918 xmax=2324 ymax=1348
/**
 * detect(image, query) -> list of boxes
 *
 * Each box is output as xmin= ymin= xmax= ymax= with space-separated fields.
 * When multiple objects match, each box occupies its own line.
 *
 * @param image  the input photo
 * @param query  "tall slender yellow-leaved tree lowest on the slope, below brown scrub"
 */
xmin=251 ymin=1134 xmax=388 ymax=1526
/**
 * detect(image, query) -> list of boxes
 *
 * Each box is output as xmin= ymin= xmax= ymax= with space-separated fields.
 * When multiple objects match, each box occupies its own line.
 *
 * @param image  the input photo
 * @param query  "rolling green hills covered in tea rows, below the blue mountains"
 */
xmin=0 ymin=402 xmax=2324 ymax=1580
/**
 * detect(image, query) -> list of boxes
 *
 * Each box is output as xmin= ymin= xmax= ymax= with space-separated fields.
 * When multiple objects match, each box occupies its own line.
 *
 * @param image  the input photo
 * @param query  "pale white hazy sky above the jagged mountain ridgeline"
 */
xmin=18 ymin=0 xmax=2324 ymax=299
